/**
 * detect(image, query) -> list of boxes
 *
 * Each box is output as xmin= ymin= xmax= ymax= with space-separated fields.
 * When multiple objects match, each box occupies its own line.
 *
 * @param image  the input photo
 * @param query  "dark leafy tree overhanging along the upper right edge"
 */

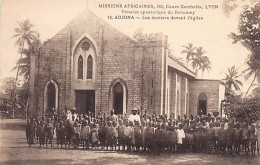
xmin=229 ymin=3 xmax=260 ymax=96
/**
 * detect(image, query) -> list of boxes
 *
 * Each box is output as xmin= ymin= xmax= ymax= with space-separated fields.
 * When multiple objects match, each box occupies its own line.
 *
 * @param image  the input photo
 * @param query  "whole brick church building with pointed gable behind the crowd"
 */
xmin=28 ymin=11 xmax=224 ymax=117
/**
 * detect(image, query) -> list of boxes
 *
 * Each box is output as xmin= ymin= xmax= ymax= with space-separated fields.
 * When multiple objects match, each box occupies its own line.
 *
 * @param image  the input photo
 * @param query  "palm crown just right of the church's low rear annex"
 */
xmin=223 ymin=65 xmax=243 ymax=93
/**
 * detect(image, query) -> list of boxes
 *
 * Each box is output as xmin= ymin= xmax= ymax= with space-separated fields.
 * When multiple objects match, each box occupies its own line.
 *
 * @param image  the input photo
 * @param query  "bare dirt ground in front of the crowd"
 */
xmin=0 ymin=122 xmax=260 ymax=165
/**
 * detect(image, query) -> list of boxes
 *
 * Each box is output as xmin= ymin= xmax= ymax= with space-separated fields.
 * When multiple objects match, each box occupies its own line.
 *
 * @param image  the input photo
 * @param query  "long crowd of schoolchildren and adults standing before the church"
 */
xmin=26 ymin=108 xmax=260 ymax=155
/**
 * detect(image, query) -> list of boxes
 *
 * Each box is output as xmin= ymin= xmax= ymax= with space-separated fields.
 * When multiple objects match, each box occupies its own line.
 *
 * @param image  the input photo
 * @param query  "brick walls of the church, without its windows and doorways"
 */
xmin=29 ymin=11 xmax=223 ymax=117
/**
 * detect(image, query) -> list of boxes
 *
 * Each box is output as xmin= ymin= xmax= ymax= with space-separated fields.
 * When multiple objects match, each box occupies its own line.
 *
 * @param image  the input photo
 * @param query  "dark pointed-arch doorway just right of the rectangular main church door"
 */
xmin=113 ymin=82 xmax=124 ymax=114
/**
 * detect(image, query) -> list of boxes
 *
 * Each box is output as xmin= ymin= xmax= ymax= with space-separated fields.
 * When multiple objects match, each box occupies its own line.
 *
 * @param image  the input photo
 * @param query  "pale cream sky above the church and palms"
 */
xmin=0 ymin=0 xmax=256 ymax=91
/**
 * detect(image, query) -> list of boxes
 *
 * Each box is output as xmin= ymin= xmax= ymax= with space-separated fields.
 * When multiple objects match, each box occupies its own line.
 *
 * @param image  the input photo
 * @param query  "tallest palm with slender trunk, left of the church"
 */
xmin=13 ymin=20 xmax=36 ymax=86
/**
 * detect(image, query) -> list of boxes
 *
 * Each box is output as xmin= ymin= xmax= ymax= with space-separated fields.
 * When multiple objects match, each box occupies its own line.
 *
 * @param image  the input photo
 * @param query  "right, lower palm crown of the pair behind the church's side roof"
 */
xmin=191 ymin=47 xmax=209 ymax=74
